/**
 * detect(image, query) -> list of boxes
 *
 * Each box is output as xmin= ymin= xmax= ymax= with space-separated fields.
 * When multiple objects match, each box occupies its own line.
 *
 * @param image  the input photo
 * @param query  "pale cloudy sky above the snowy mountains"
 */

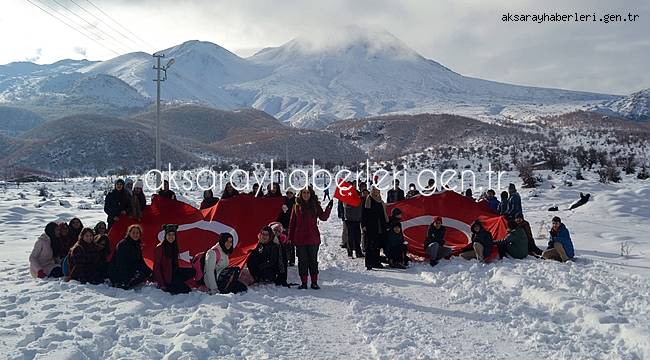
xmin=0 ymin=0 xmax=650 ymax=93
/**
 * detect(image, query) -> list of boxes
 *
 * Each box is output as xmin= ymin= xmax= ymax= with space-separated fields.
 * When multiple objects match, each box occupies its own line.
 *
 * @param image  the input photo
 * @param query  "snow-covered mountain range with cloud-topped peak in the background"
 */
xmin=0 ymin=27 xmax=632 ymax=127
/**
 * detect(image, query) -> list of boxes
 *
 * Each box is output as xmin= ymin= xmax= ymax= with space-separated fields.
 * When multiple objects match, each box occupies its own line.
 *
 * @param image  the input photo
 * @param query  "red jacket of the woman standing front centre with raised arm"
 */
xmin=288 ymin=204 xmax=332 ymax=246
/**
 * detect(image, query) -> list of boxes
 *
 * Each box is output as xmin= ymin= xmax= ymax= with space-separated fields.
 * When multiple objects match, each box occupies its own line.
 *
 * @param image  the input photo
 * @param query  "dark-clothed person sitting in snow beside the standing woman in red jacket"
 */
xmin=246 ymin=226 xmax=282 ymax=285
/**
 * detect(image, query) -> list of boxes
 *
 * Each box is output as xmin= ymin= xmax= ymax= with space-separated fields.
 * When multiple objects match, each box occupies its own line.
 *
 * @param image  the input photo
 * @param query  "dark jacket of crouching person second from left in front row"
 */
xmin=68 ymin=241 xmax=106 ymax=284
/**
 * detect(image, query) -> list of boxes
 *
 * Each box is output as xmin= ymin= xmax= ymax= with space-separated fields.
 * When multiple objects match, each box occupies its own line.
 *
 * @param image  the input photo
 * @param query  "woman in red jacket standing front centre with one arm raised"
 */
xmin=288 ymin=186 xmax=334 ymax=290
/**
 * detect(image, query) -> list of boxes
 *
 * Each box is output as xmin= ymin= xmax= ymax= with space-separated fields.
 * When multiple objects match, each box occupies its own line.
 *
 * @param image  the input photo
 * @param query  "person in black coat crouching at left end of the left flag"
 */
xmin=108 ymin=225 xmax=152 ymax=290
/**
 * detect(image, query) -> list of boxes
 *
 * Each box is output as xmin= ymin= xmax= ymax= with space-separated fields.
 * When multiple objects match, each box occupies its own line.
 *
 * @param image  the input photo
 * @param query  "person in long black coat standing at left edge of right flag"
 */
xmin=361 ymin=187 xmax=388 ymax=270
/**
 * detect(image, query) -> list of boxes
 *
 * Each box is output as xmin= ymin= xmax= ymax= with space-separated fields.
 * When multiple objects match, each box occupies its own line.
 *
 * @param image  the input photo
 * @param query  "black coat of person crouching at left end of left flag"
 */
xmin=108 ymin=236 xmax=151 ymax=285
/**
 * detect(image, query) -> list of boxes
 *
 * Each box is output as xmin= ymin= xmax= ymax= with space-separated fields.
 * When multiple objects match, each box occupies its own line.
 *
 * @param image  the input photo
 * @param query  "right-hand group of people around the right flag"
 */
xmin=338 ymin=180 xmax=574 ymax=270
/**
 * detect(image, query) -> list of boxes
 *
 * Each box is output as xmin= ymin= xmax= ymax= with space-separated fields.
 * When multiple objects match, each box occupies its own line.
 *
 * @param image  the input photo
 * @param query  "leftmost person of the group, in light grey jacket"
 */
xmin=29 ymin=222 xmax=63 ymax=279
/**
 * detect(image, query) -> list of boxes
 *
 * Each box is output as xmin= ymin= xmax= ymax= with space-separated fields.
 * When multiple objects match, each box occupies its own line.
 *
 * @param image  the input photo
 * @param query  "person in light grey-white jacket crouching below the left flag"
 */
xmin=197 ymin=233 xmax=247 ymax=294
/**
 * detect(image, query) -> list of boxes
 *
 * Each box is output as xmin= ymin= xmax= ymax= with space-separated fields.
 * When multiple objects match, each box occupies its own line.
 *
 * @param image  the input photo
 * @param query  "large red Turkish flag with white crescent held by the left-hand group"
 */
xmin=108 ymin=195 xmax=284 ymax=268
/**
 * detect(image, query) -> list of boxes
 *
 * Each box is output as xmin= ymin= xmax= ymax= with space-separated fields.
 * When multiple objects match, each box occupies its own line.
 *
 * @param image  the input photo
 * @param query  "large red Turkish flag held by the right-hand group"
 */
xmin=387 ymin=190 xmax=507 ymax=257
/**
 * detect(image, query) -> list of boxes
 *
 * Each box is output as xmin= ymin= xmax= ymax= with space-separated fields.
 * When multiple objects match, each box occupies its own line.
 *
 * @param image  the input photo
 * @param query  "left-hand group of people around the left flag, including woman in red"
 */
xmin=29 ymin=179 xmax=333 ymax=294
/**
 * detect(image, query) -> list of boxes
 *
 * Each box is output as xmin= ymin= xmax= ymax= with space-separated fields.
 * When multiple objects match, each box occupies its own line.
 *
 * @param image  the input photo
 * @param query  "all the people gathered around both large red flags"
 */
xmin=29 ymin=179 xmax=574 ymax=294
